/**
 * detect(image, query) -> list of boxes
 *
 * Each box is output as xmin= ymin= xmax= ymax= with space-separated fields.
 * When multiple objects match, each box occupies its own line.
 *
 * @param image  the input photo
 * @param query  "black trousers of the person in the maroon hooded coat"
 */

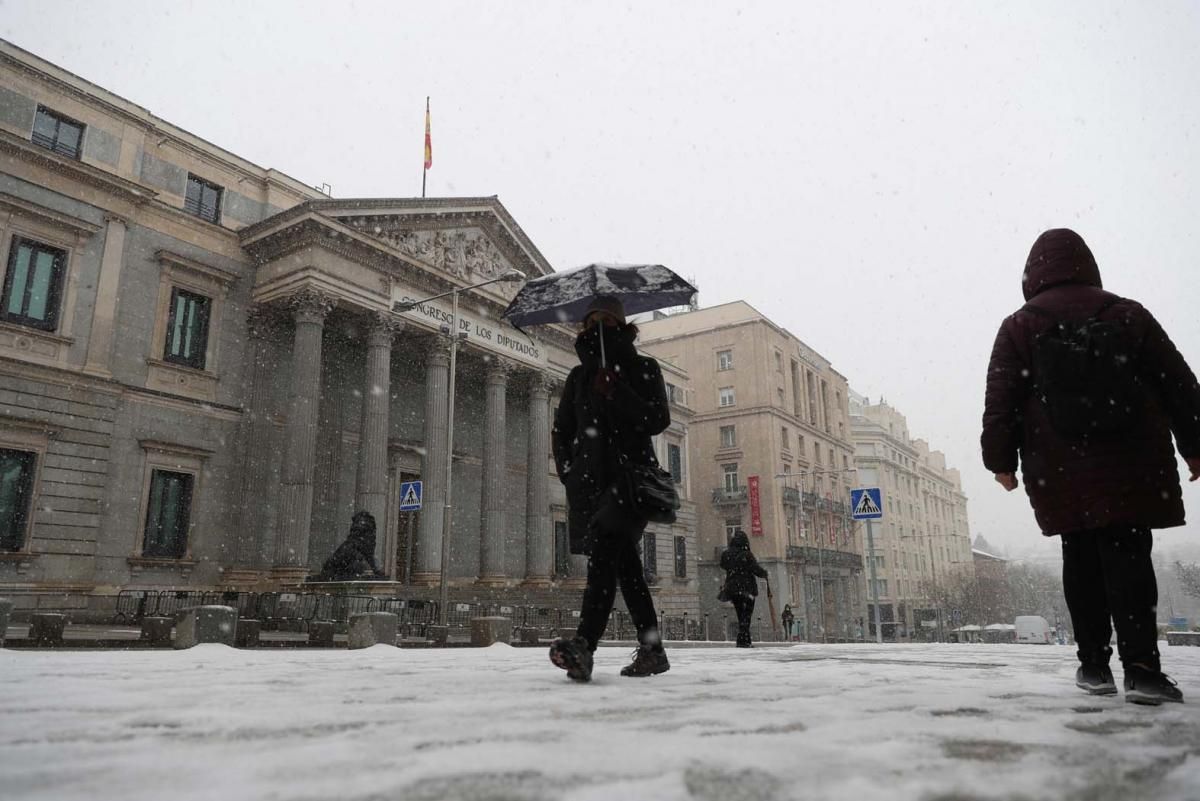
xmin=1062 ymin=525 xmax=1162 ymax=670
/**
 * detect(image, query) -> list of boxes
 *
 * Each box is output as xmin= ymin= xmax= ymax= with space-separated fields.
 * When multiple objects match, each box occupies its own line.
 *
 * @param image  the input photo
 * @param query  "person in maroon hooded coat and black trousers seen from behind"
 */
xmin=982 ymin=229 xmax=1200 ymax=704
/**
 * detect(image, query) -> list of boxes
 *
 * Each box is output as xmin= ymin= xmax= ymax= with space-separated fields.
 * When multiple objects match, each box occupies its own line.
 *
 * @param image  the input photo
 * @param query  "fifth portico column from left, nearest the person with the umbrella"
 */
xmin=524 ymin=373 xmax=554 ymax=586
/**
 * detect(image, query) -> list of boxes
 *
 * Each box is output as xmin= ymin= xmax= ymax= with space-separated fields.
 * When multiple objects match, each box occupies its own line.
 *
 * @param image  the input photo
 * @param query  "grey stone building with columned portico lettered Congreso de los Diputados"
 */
xmin=0 ymin=41 xmax=698 ymax=619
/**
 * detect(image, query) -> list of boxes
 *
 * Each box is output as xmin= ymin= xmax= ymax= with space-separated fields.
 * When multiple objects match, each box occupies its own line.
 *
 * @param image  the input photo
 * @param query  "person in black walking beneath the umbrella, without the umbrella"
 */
xmin=550 ymin=297 xmax=671 ymax=681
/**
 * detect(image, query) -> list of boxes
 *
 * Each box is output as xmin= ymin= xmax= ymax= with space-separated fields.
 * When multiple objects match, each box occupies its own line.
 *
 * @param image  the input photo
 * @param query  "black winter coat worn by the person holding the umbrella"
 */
xmin=552 ymin=326 xmax=671 ymax=555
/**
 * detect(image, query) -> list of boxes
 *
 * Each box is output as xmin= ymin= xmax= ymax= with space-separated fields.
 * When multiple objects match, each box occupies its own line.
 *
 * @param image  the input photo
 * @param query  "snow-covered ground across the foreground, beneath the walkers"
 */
xmin=0 ymin=643 xmax=1200 ymax=801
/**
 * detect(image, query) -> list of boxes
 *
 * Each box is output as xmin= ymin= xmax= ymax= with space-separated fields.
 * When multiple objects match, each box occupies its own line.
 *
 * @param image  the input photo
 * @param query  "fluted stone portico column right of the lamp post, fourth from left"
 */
xmin=479 ymin=357 xmax=510 ymax=584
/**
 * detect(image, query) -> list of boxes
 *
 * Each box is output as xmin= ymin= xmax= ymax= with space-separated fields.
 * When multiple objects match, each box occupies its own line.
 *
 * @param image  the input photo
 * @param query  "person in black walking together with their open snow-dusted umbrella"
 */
xmin=504 ymin=264 xmax=696 ymax=681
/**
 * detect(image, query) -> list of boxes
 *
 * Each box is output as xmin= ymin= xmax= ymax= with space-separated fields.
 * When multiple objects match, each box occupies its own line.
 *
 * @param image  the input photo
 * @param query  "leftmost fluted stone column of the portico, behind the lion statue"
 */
xmin=274 ymin=289 xmax=334 ymax=582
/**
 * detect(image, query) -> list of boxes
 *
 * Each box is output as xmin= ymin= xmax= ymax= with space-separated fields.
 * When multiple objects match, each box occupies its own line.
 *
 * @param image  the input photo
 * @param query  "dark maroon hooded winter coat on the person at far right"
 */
xmin=980 ymin=229 xmax=1200 ymax=536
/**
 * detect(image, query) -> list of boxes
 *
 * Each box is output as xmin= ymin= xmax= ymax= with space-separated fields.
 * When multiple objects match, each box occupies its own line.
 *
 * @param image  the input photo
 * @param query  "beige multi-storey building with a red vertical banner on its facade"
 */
xmin=640 ymin=301 xmax=865 ymax=639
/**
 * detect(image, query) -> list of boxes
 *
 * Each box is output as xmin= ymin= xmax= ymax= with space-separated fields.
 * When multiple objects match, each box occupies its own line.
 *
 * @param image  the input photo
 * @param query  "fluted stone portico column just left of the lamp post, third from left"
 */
xmin=412 ymin=339 xmax=450 ymax=585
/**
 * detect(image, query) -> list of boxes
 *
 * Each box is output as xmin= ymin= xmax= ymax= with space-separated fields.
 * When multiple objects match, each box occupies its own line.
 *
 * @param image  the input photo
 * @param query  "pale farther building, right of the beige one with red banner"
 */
xmin=850 ymin=392 xmax=974 ymax=640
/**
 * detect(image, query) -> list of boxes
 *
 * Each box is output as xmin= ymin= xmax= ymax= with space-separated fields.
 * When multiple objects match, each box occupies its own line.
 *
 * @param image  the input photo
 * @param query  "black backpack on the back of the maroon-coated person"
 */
xmin=1024 ymin=297 xmax=1145 ymax=440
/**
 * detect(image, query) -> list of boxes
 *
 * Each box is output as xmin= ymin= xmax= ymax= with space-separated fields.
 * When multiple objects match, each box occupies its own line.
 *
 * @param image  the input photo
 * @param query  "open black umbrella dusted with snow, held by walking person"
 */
xmin=502 ymin=264 xmax=696 ymax=365
